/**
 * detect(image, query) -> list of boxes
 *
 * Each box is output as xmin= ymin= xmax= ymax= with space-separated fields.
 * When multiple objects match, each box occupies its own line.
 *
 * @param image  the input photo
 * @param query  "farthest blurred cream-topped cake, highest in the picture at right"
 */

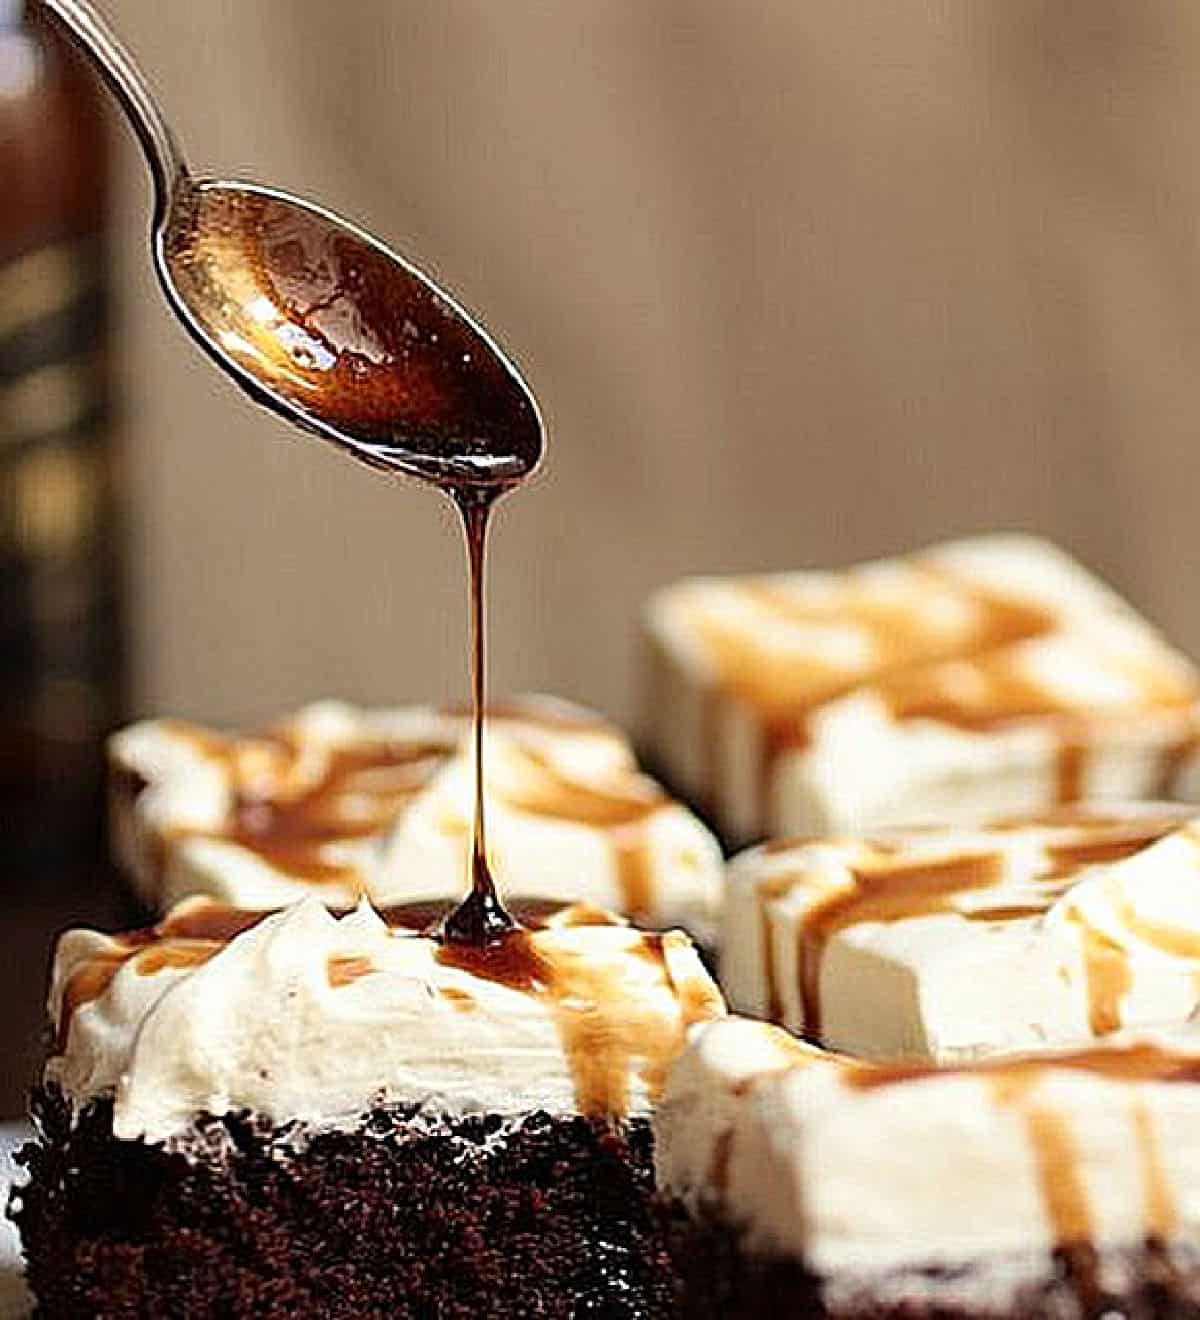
xmin=646 ymin=536 xmax=1200 ymax=842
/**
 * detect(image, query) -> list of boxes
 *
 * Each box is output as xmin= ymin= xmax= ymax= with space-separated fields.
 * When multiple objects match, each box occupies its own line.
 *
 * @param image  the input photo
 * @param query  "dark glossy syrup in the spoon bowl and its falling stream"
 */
xmin=165 ymin=186 xmax=543 ymax=945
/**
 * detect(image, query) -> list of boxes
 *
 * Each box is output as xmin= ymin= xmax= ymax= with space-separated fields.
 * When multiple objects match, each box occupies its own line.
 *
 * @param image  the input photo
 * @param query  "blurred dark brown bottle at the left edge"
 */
xmin=0 ymin=0 xmax=123 ymax=871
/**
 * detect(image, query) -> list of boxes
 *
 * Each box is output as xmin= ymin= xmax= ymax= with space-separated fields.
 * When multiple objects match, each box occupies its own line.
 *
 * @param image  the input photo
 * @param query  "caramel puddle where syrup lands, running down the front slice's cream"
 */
xmin=437 ymin=929 xmax=723 ymax=1118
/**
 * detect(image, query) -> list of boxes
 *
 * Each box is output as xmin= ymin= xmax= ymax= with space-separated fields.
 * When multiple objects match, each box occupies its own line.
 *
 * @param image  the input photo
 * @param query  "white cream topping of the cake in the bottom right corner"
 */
xmin=655 ymin=1018 xmax=1200 ymax=1293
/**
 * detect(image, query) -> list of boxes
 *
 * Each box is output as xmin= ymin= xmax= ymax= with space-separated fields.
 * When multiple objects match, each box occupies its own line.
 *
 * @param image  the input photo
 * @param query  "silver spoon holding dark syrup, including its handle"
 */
xmin=42 ymin=0 xmax=545 ymax=494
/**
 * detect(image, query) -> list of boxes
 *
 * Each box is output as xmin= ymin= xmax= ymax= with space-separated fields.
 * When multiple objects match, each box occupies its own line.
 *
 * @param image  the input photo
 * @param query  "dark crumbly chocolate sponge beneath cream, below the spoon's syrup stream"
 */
xmin=9 ymin=1086 xmax=673 ymax=1320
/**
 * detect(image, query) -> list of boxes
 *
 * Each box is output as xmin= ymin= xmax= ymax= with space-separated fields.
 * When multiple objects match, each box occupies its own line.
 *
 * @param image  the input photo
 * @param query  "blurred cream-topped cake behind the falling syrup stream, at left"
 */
xmin=110 ymin=697 xmax=721 ymax=939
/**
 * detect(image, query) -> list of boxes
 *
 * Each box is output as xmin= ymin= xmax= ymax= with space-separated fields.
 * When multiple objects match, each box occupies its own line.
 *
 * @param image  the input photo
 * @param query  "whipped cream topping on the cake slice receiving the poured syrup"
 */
xmin=46 ymin=899 xmax=723 ymax=1142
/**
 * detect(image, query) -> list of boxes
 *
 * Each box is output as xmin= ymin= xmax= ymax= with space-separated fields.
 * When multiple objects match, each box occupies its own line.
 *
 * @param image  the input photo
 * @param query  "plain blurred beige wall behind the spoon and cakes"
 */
xmin=100 ymin=0 xmax=1200 ymax=719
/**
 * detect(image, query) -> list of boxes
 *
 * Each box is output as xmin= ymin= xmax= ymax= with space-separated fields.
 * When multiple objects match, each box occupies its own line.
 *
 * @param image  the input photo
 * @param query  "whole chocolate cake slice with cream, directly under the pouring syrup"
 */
xmin=9 ymin=899 xmax=723 ymax=1320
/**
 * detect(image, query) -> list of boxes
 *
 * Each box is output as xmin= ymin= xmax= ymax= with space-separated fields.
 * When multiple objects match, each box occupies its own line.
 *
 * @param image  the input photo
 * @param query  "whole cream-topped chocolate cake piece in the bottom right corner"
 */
xmin=653 ymin=1018 xmax=1200 ymax=1320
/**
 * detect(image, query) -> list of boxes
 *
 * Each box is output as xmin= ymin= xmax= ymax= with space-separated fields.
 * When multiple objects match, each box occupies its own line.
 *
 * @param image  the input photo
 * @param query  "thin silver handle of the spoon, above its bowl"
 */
xmin=42 ymin=0 xmax=187 ymax=211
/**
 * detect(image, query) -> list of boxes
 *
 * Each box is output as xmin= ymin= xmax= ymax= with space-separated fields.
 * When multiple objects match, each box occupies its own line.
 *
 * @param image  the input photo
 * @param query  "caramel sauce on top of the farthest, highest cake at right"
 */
xmin=692 ymin=561 xmax=1200 ymax=829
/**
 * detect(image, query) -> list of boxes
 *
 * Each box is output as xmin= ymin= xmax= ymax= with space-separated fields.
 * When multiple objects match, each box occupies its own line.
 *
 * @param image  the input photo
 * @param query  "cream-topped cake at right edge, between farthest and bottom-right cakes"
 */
xmin=721 ymin=804 xmax=1200 ymax=1061
